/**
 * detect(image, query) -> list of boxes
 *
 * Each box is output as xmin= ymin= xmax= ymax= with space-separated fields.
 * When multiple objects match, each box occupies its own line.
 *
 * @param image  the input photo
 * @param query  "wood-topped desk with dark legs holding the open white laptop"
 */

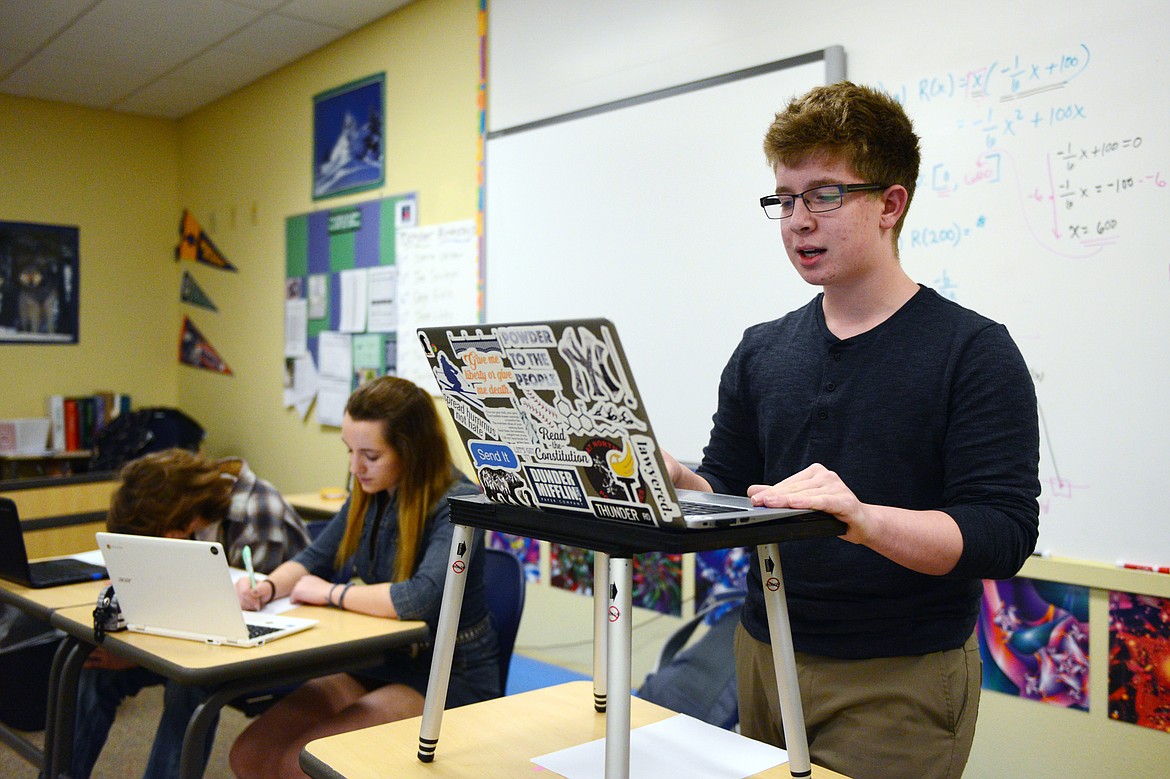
xmin=44 ymin=602 xmax=429 ymax=777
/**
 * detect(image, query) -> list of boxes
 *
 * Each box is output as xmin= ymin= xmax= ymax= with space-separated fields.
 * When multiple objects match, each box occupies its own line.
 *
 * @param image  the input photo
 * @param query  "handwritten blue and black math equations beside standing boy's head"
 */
xmin=887 ymin=43 xmax=1166 ymax=258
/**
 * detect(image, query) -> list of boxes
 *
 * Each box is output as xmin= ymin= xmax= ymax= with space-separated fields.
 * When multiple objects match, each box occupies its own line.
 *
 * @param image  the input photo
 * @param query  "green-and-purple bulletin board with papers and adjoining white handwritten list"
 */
xmin=284 ymin=194 xmax=480 ymax=426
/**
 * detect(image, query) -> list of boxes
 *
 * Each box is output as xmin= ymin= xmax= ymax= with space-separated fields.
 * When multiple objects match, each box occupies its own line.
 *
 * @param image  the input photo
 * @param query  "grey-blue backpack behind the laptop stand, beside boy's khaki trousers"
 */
xmin=638 ymin=591 xmax=745 ymax=730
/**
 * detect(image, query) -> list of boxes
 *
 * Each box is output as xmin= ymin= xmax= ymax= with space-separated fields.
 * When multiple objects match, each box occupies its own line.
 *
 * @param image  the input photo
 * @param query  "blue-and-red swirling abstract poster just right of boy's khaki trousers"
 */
xmin=978 ymin=577 xmax=1089 ymax=711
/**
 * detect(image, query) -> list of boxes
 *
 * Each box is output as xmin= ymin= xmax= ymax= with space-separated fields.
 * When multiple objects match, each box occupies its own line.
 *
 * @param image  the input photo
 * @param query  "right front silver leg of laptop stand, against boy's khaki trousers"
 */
xmin=758 ymin=544 xmax=812 ymax=777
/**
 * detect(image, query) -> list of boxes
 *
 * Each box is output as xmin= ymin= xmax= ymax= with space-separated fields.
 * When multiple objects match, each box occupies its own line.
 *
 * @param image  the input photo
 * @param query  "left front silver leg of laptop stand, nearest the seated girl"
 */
xmin=419 ymin=525 xmax=474 ymax=763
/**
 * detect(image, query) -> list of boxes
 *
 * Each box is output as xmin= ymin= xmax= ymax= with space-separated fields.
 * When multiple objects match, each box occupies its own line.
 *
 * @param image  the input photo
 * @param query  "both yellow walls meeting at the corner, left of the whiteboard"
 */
xmin=0 ymin=0 xmax=480 ymax=492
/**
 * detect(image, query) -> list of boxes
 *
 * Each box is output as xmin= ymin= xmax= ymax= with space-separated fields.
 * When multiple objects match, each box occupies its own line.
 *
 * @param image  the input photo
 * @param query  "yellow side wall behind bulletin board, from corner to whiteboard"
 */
xmin=179 ymin=0 xmax=480 ymax=492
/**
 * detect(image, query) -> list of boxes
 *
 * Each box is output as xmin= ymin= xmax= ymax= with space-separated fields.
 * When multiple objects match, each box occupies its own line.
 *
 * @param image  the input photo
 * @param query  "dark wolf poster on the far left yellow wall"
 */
xmin=0 ymin=216 xmax=80 ymax=344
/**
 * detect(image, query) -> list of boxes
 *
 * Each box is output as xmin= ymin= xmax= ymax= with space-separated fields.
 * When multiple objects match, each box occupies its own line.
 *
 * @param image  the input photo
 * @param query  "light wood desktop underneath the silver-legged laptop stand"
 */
xmin=301 ymin=682 xmax=844 ymax=779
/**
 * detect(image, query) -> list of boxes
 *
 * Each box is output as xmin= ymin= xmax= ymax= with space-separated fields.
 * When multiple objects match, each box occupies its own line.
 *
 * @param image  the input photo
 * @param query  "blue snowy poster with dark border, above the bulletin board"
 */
xmin=312 ymin=73 xmax=386 ymax=199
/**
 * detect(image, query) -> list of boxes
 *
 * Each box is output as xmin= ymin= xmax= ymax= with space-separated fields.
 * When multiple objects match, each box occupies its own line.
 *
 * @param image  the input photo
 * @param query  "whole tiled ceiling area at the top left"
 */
xmin=0 ymin=0 xmax=411 ymax=117
